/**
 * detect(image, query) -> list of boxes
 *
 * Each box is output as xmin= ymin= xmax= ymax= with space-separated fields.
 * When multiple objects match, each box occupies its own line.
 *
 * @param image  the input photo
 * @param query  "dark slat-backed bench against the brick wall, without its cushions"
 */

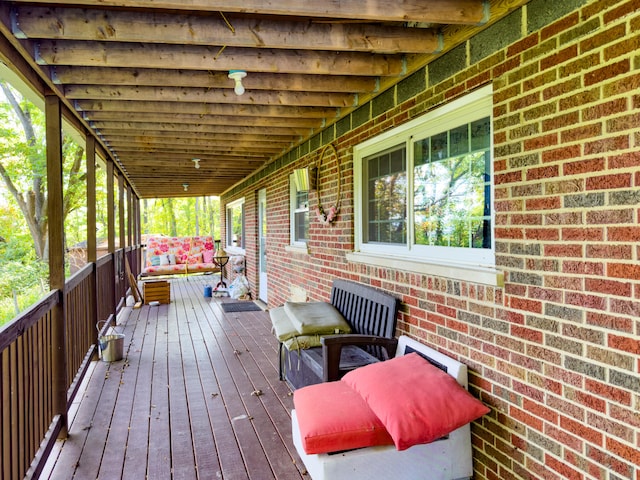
xmin=280 ymin=279 xmax=400 ymax=388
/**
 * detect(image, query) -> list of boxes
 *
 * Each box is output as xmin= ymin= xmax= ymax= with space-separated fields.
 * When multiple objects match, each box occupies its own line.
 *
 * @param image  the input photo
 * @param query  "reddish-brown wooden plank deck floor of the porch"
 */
xmin=42 ymin=276 xmax=308 ymax=480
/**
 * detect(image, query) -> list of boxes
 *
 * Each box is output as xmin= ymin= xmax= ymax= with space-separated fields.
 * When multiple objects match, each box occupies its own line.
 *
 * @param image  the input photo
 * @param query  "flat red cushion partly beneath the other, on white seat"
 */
xmin=293 ymin=382 xmax=393 ymax=454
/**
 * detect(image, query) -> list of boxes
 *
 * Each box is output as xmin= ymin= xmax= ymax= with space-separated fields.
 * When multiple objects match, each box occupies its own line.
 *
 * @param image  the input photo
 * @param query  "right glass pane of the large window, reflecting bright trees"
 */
xmin=414 ymin=117 xmax=491 ymax=248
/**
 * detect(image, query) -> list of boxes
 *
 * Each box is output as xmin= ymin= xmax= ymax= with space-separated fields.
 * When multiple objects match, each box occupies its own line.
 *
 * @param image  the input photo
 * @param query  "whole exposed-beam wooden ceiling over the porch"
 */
xmin=0 ymin=0 xmax=526 ymax=198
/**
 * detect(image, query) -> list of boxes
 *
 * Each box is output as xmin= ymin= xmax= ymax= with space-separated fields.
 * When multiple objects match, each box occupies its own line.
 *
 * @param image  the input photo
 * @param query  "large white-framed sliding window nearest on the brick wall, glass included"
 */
xmin=350 ymin=87 xmax=500 ymax=283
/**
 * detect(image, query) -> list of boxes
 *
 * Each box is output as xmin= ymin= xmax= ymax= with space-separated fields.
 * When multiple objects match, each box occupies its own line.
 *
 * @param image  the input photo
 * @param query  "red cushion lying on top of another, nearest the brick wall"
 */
xmin=342 ymin=353 xmax=490 ymax=450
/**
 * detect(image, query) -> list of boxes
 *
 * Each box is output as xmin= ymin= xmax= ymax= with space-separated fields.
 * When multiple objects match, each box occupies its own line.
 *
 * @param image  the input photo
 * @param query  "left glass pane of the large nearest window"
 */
xmin=363 ymin=145 xmax=407 ymax=244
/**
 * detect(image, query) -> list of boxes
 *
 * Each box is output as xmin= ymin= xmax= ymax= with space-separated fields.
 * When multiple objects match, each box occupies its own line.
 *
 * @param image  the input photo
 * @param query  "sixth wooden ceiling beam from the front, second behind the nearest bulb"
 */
xmin=73 ymin=100 xmax=340 ymax=119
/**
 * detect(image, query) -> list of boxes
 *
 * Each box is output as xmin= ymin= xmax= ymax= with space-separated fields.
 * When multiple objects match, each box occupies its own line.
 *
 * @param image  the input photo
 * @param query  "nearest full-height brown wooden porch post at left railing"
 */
xmin=45 ymin=92 xmax=68 ymax=437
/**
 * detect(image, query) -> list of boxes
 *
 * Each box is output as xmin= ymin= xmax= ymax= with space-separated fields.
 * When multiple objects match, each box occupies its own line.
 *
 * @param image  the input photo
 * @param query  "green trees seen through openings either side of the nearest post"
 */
xmin=0 ymin=81 xmax=86 ymax=325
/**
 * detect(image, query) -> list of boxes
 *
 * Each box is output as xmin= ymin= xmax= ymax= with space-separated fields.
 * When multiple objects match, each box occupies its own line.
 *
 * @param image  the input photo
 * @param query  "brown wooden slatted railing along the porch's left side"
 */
xmin=0 ymin=248 xmax=140 ymax=480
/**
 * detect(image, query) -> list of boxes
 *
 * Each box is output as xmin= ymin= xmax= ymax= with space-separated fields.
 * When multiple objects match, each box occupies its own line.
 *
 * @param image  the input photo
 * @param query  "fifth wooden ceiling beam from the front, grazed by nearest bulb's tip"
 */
xmin=64 ymin=85 xmax=357 ymax=108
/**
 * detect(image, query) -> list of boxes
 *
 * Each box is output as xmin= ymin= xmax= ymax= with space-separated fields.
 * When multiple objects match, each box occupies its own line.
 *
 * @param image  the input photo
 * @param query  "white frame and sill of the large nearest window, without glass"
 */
xmin=347 ymin=86 xmax=503 ymax=285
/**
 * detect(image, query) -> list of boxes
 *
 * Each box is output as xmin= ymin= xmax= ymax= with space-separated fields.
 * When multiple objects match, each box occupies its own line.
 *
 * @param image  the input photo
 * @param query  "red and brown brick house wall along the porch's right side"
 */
xmin=225 ymin=0 xmax=640 ymax=480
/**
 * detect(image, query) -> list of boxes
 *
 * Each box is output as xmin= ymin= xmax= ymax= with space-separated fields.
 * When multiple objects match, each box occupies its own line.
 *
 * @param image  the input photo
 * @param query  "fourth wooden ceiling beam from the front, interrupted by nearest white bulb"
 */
xmin=51 ymin=65 xmax=378 ymax=93
